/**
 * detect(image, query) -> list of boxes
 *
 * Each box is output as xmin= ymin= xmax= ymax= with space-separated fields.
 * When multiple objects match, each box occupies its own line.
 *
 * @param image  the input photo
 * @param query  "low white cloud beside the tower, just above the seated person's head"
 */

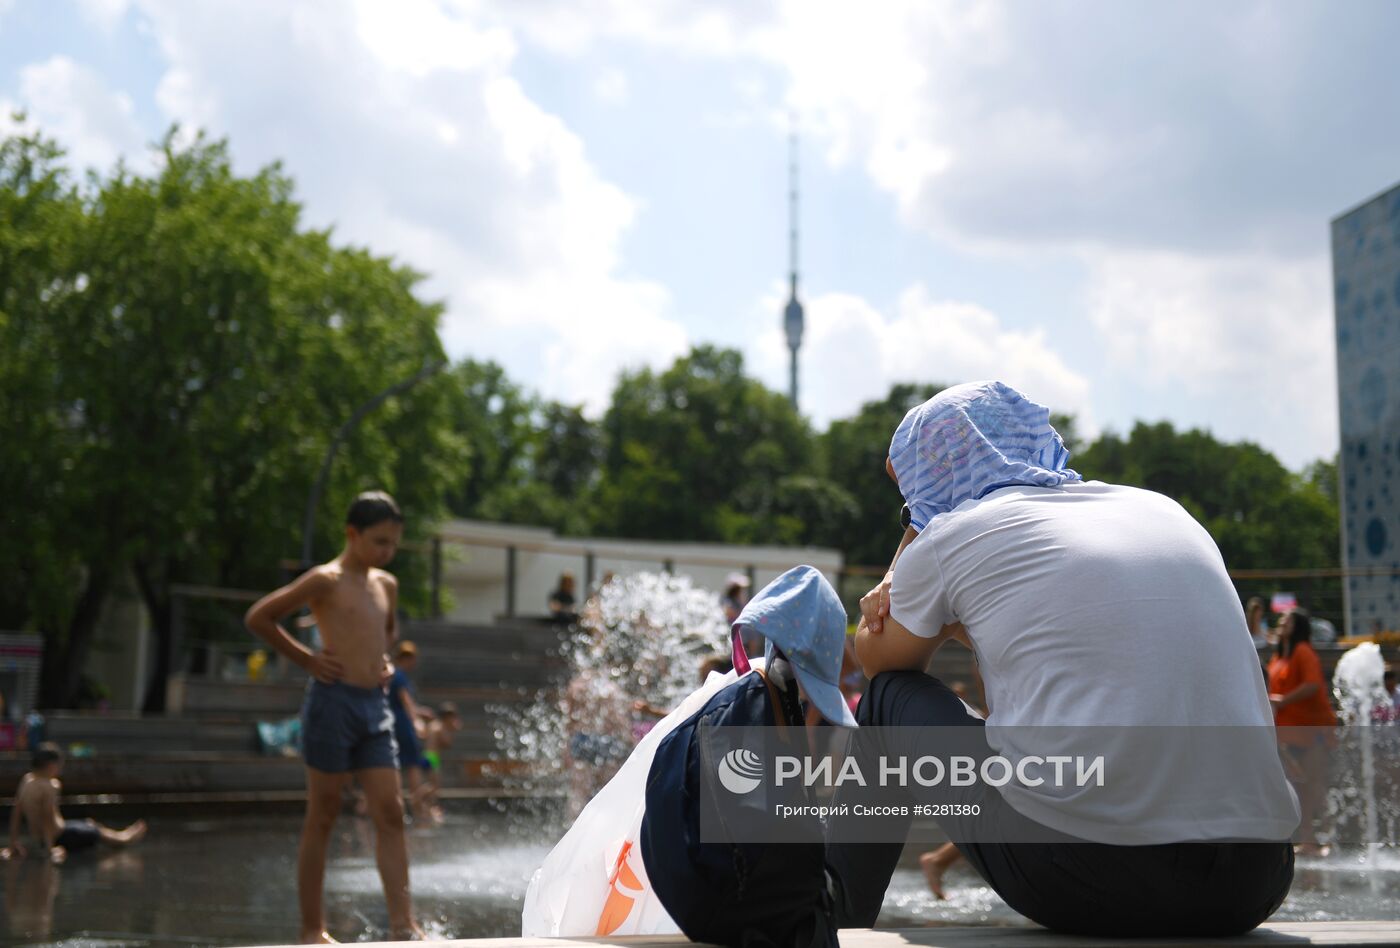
xmin=753 ymin=278 xmax=1098 ymax=435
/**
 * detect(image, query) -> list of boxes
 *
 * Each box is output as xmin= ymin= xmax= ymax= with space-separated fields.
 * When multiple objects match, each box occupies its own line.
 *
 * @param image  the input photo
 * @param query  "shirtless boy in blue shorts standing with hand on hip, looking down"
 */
xmin=244 ymin=492 xmax=423 ymax=944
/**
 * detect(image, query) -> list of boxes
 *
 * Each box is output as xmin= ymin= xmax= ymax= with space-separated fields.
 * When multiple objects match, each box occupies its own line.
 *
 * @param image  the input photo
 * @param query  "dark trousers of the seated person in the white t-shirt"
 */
xmin=827 ymin=672 xmax=1294 ymax=937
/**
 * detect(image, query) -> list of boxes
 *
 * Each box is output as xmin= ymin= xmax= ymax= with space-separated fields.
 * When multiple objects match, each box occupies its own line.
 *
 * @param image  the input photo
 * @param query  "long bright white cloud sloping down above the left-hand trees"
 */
xmin=133 ymin=0 xmax=687 ymax=409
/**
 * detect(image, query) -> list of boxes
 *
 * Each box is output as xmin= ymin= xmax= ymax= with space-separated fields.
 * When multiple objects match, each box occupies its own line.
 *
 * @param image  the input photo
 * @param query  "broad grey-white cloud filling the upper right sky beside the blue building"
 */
xmin=476 ymin=0 xmax=1383 ymax=462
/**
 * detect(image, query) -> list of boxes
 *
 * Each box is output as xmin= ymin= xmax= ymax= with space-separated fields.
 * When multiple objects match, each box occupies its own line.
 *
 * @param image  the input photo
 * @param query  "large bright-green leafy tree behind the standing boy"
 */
xmin=0 ymin=126 xmax=462 ymax=710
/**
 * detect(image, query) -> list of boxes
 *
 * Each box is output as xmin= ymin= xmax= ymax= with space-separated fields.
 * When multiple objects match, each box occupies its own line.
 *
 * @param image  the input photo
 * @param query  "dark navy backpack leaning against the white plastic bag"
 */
xmin=640 ymin=662 xmax=839 ymax=948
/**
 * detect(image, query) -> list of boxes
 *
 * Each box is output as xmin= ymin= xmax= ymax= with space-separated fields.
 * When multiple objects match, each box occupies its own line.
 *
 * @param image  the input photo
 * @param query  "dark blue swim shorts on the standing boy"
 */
xmin=301 ymin=681 xmax=399 ymax=773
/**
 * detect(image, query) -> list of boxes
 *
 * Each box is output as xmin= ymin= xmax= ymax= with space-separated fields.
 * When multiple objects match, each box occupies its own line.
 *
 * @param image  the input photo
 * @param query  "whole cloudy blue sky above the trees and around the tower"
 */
xmin=0 ymin=0 xmax=1400 ymax=469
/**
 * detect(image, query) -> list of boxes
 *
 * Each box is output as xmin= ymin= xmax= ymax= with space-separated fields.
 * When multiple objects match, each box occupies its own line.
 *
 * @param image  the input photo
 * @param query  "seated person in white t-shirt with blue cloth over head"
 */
xmin=827 ymin=382 xmax=1298 ymax=937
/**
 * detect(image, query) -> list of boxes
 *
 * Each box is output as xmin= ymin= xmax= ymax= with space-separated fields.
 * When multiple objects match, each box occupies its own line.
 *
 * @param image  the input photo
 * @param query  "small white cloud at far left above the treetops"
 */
xmin=4 ymin=56 xmax=146 ymax=171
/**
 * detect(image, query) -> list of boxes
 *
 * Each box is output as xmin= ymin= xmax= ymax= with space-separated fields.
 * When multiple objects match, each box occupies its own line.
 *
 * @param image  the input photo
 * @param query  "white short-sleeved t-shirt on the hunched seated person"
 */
xmin=890 ymin=482 xmax=1299 ymax=844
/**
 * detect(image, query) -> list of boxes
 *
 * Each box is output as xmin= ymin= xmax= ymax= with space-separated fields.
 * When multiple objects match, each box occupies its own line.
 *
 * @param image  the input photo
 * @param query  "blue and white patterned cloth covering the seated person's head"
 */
xmin=889 ymin=382 xmax=1081 ymax=531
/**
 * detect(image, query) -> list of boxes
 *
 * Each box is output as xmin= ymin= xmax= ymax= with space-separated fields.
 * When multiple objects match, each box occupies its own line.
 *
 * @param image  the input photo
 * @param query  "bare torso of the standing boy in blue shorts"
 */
xmin=309 ymin=560 xmax=399 ymax=688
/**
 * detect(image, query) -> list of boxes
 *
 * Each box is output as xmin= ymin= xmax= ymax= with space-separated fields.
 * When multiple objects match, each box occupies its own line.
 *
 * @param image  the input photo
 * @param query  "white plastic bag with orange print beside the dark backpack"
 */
xmin=521 ymin=661 xmax=762 ymax=938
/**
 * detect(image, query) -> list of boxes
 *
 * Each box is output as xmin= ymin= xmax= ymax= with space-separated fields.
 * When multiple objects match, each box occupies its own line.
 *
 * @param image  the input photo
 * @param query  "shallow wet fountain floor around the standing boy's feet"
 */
xmin=0 ymin=807 xmax=1400 ymax=947
